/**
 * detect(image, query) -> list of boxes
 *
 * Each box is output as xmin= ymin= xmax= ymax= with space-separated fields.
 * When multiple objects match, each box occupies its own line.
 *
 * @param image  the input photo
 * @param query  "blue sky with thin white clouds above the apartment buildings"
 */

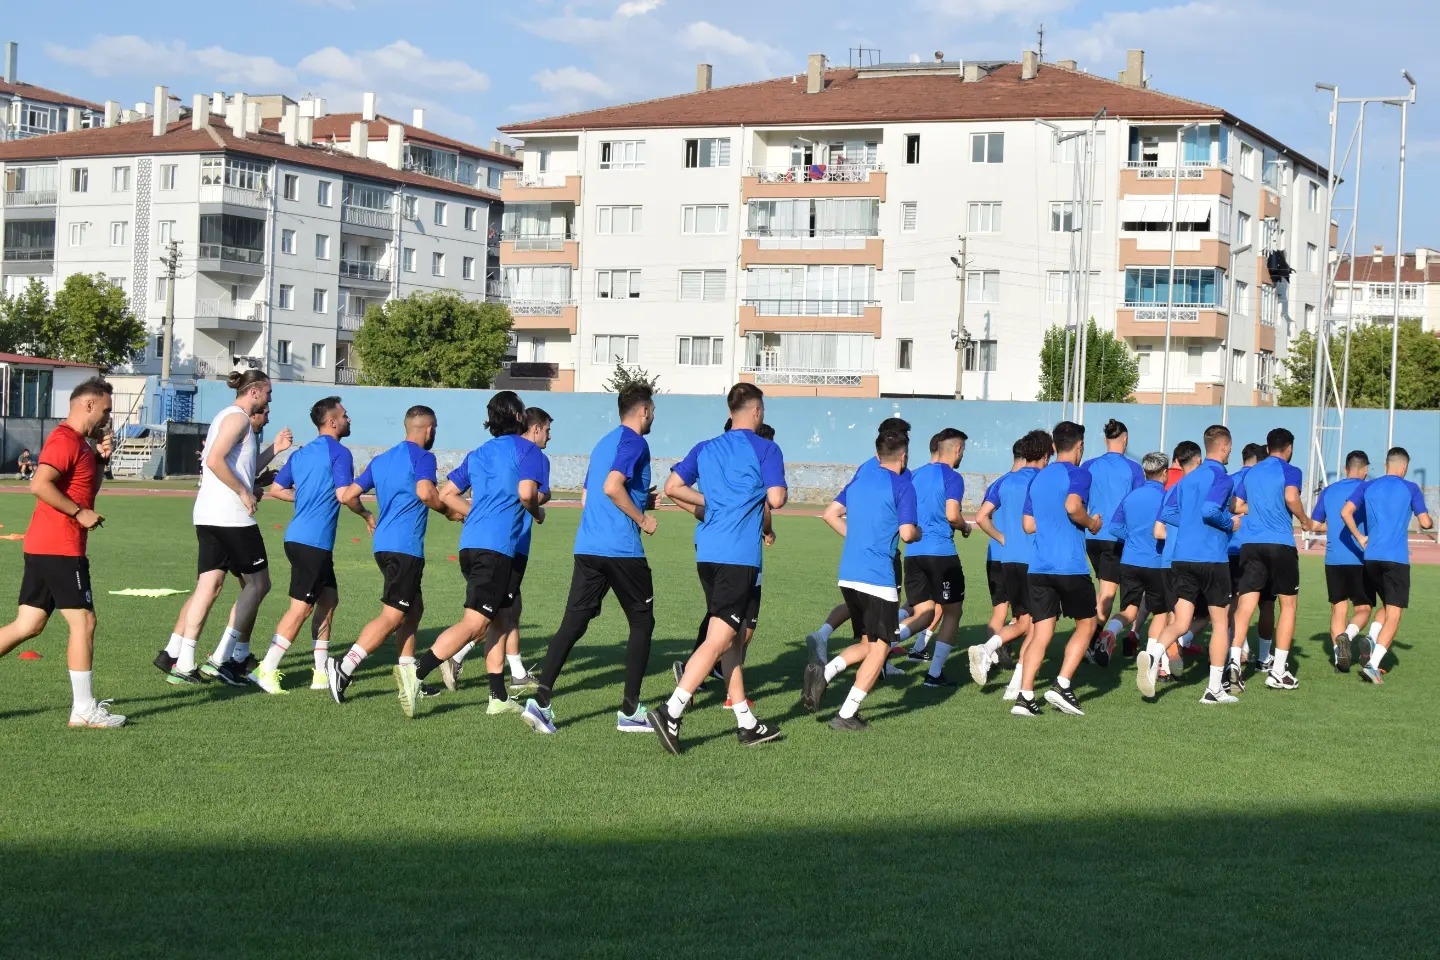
xmin=0 ymin=0 xmax=1440 ymax=249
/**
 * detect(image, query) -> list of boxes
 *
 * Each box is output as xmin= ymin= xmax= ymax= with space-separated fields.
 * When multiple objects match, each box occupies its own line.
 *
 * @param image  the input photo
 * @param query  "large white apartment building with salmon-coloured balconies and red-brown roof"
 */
xmin=501 ymin=50 xmax=1331 ymax=403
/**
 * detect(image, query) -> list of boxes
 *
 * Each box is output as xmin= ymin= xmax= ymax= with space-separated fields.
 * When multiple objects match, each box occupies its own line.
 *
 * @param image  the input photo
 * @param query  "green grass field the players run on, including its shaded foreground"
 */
xmin=0 ymin=495 xmax=1440 ymax=960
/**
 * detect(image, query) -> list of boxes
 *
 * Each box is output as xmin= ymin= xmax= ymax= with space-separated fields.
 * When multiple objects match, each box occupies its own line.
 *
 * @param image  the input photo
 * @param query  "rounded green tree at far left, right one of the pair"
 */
xmin=43 ymin=273 xmax=145 ymax=370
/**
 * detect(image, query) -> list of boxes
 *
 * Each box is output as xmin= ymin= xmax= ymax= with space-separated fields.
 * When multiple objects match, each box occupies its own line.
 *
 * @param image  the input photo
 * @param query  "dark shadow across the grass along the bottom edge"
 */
xmin=0 ymin=799 xmax=1440 ymax=960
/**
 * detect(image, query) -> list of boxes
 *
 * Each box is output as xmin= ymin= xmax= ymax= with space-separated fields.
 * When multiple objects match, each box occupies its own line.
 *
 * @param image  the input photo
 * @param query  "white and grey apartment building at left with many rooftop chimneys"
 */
xmin=0 ymin=88 xmax=516 ymax=383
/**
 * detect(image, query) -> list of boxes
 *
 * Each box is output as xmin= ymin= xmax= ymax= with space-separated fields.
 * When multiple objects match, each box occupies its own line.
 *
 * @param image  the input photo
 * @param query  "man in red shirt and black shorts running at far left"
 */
xmin=0 ymin=377 xmax=125 ymax=728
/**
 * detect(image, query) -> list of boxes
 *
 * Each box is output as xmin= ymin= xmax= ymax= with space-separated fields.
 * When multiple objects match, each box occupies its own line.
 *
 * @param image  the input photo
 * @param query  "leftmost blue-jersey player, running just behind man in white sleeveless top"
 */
xmin=253 ymin=397 xmax=374 ymax=694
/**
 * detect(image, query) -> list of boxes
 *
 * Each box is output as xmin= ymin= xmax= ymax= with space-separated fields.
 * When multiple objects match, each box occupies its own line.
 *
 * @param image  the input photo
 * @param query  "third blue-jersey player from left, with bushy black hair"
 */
xmin=395 ymin=390 xmax=546 ymax=717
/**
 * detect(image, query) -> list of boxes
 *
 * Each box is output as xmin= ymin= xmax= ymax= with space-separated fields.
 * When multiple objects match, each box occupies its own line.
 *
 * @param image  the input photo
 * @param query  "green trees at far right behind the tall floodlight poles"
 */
xmin=1276 ymin=321 xmax=1440 ymax=410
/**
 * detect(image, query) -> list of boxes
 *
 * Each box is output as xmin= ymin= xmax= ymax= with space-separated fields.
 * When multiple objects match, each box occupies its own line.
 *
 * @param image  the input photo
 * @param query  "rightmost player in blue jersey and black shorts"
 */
xmin=1341 ymin=446 xmax=1434 ymax=684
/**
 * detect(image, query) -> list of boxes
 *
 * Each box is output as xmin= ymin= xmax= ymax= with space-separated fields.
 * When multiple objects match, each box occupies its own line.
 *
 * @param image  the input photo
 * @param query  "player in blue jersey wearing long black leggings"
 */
xmin=521 ymin=384 xmax=655 ymax=734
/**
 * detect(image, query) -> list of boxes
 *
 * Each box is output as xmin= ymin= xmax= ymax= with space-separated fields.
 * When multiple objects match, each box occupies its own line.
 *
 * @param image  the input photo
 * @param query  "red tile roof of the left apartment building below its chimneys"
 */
xmin=0 ymin=115 xmax=500 ymax=200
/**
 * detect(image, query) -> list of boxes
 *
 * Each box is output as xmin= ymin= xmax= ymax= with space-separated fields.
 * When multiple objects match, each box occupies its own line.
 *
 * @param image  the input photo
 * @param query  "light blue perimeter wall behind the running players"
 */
xmin=194 ymin=380 xmax=1440 ymax=505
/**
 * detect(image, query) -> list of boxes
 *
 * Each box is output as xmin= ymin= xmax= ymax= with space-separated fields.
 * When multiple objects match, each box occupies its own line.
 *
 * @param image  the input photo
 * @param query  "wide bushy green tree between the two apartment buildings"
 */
xmin=356 ymin=291 xmax=511 ymax=389
